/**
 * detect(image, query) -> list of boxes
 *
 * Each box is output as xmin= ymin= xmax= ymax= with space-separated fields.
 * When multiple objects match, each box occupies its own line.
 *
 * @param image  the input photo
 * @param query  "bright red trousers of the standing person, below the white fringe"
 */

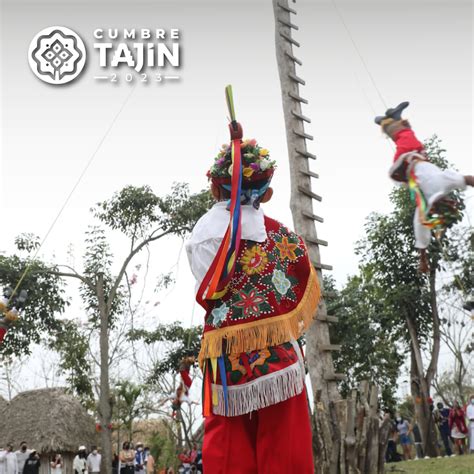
xmin=202 ymin=390 xmax=314 ymax=474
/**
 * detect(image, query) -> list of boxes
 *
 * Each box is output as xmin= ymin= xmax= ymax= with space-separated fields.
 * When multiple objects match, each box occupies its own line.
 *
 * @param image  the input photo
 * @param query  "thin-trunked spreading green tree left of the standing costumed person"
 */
xmin=0 ymin=184 xmax=211 ymax=474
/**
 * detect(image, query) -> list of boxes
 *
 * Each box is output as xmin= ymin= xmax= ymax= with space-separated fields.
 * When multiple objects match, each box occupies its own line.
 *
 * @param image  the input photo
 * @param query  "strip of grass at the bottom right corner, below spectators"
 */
xmin=385 ymin=454 xmax=474 ymax=474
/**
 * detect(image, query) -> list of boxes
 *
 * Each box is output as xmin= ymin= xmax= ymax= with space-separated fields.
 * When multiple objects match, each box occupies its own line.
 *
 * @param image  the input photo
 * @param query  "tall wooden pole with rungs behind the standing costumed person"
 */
xmin=272 ymin=0 xmax=344 ymax=472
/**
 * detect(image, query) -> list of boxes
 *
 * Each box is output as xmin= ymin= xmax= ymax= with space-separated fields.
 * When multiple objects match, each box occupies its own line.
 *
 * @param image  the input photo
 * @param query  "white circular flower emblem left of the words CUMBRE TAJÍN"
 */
xmin=28 ymin=26 xmax=86 ymax=84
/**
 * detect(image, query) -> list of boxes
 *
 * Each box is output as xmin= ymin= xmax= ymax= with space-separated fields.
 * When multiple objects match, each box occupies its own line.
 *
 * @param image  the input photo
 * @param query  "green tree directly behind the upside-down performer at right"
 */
xmin=357 ymin=137 xmax=462 ymax=456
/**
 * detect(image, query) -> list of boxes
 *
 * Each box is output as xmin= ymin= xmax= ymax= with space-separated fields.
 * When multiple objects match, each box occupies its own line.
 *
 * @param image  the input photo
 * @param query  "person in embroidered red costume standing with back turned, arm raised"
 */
xmin=186 ymin=86 xmax=320 ymax=474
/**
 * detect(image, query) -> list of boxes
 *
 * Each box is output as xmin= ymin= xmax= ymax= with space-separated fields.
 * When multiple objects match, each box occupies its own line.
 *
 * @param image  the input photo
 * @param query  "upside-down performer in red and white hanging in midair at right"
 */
xmin=375 ymin=102 xmax=474 ymax=272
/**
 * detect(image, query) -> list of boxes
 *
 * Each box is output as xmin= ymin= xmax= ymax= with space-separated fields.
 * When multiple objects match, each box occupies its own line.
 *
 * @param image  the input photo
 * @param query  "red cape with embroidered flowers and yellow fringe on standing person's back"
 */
xmin=199 ymin=217 xmax=320 ymax=365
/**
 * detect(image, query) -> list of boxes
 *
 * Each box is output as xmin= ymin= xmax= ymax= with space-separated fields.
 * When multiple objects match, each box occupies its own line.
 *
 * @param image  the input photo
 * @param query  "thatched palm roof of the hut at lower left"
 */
xmin=0 ymin=388 xmax=97 ymax=453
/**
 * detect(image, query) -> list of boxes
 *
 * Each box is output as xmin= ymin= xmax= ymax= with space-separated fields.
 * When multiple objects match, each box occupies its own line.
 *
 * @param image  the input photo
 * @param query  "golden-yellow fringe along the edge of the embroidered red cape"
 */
xmin=199 ymin=265 xmax=321 ymax=367
